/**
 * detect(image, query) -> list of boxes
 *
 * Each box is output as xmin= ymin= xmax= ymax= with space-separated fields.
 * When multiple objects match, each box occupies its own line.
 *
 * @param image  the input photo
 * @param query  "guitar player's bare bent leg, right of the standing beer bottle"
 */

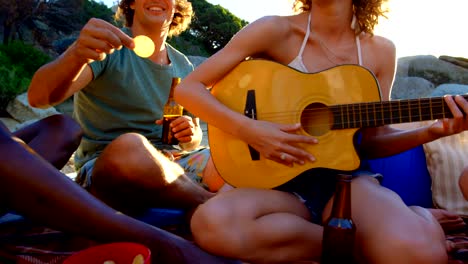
xmin=324 ymin=176 xmax=448 ymax=264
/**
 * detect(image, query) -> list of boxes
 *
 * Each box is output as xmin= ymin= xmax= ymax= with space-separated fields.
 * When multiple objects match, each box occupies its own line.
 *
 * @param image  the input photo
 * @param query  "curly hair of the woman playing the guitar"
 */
xmin=294 ymin=0 xmax=388 ymax=34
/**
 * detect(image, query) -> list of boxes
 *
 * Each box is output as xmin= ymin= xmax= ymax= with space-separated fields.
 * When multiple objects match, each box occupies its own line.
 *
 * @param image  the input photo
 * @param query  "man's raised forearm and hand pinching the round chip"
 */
xmin=28 ymin=19 xmax=134 ymax=108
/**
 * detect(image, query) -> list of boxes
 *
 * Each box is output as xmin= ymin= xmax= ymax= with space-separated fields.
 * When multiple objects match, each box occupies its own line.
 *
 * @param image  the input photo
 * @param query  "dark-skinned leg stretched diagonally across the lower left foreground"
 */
xmin=0 ymin=120 xmax=235 ymax=264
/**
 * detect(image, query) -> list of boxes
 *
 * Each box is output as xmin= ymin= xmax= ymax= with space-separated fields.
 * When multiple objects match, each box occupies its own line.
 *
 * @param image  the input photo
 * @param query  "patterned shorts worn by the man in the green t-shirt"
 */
xmin=76 ymin=148 xmax=210 ymax=188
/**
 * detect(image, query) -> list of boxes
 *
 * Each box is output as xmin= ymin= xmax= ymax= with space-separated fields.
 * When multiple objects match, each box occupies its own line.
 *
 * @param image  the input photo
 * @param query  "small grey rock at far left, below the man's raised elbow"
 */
xmin=6 ymin=93 xmax=59 ymax=122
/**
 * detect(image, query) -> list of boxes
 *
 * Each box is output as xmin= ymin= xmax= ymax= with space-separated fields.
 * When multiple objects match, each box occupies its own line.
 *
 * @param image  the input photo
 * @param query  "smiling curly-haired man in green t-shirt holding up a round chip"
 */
xmin=28 ymin=0 xmax=223 ymax=213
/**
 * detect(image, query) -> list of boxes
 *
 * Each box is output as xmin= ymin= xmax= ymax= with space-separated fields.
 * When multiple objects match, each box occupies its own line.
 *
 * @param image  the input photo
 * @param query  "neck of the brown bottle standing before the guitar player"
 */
xmin=331 ymin=175 xmax=352 ymax=219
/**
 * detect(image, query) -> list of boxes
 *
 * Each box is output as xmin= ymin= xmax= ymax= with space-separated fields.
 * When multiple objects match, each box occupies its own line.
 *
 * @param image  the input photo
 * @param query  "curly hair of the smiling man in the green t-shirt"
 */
xmin=115 ymin=0 xmax=193 ymax=37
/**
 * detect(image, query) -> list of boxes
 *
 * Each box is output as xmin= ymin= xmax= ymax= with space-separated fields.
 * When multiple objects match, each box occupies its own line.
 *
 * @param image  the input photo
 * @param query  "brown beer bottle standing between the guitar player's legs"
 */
xmin=320 ymin=174 xmax=356 ymax=264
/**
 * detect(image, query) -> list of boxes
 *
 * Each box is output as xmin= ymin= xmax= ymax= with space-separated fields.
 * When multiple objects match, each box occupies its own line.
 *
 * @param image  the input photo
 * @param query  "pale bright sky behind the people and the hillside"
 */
xmin=97 ymin=0 xmax=468 ymax=58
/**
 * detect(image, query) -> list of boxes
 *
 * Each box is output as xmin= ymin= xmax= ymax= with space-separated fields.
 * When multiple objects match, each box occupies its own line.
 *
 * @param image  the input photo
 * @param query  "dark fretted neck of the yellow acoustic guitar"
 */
xmin=330 ymin=95 xmax=468 ymax=129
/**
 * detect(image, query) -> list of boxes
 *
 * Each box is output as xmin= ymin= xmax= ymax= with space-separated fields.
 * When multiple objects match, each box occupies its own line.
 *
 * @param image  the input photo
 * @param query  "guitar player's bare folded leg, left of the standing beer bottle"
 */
xmin=191 ymin=188 xmax=322 ymax=263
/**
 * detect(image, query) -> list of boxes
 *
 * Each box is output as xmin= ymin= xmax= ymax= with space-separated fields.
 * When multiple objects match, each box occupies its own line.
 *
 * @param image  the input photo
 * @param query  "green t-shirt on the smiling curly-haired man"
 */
xmin=74 ymin=28 xmax=194 ymax=169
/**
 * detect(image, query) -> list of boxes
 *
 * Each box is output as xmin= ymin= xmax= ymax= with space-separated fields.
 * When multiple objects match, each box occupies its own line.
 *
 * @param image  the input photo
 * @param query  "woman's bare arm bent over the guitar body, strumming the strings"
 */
xmin=175 ymin=17 xmax=316 ymax=165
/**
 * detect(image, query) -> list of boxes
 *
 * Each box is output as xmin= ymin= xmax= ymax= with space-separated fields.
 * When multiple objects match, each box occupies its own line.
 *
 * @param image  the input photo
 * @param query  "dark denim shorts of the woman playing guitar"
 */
xmin=275 ymin=168 xmax=383 ymax=225
